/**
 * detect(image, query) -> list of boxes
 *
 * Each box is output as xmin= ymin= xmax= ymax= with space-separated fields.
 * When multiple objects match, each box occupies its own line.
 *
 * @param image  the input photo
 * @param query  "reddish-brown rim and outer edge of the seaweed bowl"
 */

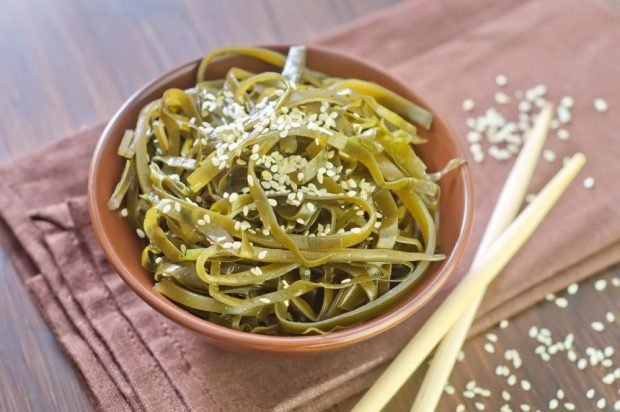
xmin=88 ymin=43 xmax=474 ymax=353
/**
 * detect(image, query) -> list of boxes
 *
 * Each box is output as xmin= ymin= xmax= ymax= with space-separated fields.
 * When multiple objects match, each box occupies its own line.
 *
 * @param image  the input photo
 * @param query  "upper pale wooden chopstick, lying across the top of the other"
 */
xmin=352 ymin=153 xmax=586 ymax=412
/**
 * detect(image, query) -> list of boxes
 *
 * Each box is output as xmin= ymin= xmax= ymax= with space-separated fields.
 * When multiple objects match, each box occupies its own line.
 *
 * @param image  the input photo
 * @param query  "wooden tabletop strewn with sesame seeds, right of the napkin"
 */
xmin=334 ymin=266 xmax=620 ymax=412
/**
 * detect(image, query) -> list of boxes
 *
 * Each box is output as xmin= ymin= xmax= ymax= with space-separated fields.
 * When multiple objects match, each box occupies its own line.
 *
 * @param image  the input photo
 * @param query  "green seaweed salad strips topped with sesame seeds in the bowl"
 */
xmin=108 ymin=46 xmax=461 ymax=335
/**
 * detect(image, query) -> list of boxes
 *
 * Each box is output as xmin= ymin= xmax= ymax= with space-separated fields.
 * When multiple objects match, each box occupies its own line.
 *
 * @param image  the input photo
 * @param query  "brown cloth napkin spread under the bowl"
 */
xmin=0 ymin=0 xmax=620 ymax=411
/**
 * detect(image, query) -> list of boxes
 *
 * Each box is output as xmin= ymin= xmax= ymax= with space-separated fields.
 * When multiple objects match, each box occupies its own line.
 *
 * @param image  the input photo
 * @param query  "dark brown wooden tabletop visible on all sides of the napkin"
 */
xmin=0 ymin=0 xmax=620 ymax=411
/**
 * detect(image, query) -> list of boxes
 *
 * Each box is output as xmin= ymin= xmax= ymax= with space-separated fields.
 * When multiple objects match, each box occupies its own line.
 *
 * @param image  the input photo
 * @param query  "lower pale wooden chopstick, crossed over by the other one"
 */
xmin=411 ymin=104 xmax=553 ymax=412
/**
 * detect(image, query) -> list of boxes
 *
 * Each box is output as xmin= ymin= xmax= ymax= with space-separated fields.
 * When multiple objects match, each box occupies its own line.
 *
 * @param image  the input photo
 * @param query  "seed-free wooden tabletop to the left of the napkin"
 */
xmin=0 ymin=0 xmax=397 ymax=412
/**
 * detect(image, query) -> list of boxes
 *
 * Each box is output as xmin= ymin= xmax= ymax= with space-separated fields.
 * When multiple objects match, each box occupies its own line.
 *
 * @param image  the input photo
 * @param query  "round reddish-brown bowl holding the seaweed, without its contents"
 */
xmin=88 ymin=46 xmax=473 ymax=354
